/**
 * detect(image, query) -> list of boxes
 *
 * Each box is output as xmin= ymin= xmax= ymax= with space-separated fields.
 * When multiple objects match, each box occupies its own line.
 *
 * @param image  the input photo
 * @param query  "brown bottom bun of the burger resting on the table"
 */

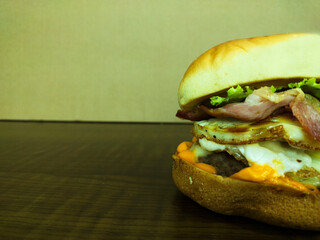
xmin=172 ymin=156 xmax=320 ymax=231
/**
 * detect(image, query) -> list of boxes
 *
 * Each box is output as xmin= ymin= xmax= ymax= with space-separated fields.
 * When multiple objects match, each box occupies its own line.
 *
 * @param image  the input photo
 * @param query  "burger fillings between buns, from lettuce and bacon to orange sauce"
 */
xmin=177 ymin=79 xmax=320 ymax=190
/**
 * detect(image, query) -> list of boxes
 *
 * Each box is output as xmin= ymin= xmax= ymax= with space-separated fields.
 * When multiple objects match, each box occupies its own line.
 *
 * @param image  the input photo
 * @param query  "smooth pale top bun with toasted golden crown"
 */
xmin=178 ymin=33 xmax=320 ymax=110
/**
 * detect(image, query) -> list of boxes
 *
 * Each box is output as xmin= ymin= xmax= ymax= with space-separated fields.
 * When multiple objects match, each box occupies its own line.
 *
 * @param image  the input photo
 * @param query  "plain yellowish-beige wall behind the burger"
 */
xmin=0 ymin=0 xmax=320 ymax=122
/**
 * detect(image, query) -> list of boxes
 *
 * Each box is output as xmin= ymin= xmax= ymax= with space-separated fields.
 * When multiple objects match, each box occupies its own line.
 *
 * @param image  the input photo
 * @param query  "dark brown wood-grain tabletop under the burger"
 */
xmin=0 ymin=122 xmax=320 ymax=239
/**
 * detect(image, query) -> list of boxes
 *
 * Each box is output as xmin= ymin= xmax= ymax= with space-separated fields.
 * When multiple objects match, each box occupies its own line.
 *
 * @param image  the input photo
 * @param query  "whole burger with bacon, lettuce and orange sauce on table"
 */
xmin=172 ymin=33 xmax=320 ymax=231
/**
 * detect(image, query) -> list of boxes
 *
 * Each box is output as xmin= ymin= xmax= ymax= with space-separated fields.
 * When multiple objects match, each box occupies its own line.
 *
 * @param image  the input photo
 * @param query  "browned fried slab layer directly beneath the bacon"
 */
xmin=193 ymin=114 xmax=320 ymax=151
